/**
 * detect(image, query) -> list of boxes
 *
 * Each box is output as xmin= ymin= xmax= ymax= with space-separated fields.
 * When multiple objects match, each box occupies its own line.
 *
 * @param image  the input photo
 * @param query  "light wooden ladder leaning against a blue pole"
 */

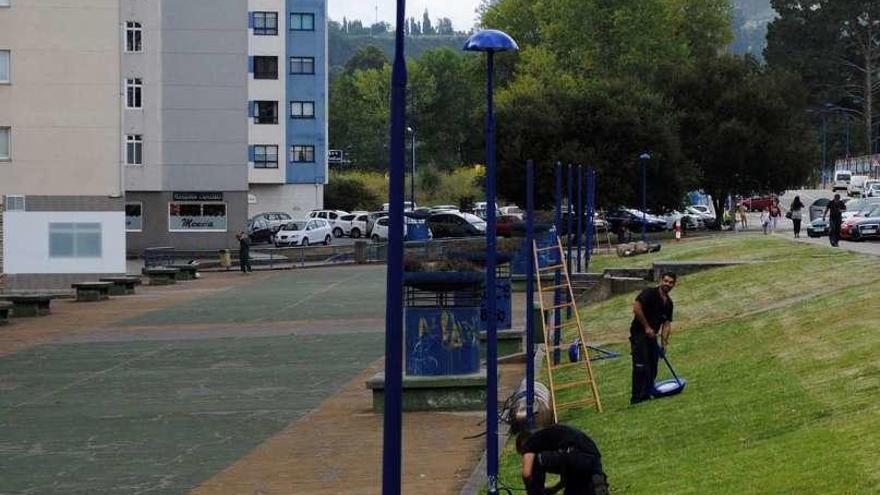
xmin=533 ymin=237 xmax=602 ymax=422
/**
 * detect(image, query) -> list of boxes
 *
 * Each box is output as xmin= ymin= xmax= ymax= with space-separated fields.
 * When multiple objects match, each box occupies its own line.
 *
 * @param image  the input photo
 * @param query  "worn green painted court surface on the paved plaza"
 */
xmin=0 ymin=266 xmax=385 ymax=495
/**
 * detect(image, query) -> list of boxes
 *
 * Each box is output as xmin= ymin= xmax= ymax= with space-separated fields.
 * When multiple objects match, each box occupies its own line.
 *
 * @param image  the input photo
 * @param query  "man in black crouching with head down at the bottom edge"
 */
xmin=516 ymin=424 xmax=610 ymax=495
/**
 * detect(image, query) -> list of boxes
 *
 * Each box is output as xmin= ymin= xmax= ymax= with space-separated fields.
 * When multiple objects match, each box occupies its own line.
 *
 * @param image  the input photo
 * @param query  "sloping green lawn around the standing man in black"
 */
xmin=501 ymin=236 xmax=880 ymax=495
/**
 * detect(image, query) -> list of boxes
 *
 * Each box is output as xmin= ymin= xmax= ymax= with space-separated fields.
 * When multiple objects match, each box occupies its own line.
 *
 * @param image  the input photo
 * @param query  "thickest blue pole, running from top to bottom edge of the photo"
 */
xmin=382 ymin=0 xmax=407 ymax=495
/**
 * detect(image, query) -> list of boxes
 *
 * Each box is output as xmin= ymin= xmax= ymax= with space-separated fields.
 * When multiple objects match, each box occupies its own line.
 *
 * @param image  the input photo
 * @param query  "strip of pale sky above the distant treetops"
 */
xmin=327 ymin=0 xmax=480 ymax=31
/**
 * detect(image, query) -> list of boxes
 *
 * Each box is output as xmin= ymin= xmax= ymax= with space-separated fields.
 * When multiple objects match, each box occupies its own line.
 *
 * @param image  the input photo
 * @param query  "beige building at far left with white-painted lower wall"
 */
xmin=0 ymin=0 xmax=125 ymax=290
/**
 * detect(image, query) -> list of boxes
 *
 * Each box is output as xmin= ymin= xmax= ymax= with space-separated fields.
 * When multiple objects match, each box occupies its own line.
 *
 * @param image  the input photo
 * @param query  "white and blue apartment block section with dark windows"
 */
xmin=248 ymin=0 xmax=328 ymax=218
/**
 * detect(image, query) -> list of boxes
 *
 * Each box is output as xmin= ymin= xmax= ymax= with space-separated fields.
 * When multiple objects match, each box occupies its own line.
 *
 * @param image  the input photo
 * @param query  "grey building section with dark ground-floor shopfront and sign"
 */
xmin=118 ymin=0 xmax=248 ymax=254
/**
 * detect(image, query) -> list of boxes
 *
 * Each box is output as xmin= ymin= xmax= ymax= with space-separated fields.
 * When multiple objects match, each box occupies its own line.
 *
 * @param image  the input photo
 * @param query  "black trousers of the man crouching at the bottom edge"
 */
xmin=526 ymin=451 xmax=608 ymax=495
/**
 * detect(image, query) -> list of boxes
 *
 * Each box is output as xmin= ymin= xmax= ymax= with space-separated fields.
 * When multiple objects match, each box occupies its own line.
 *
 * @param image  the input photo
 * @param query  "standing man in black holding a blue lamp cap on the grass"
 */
xmin=629 ymin=273 xmax=677 ymax=404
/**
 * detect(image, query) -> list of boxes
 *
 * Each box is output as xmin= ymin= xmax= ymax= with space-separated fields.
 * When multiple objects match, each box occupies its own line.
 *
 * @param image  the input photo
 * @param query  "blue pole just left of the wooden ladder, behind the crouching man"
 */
xmin=526 ymin=160 xmax=535 ymax=428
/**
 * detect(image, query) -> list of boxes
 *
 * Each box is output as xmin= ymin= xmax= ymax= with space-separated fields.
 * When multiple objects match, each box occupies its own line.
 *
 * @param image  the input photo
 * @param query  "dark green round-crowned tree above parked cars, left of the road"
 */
xmin=668 ymin=55 xmax=815 ymax=223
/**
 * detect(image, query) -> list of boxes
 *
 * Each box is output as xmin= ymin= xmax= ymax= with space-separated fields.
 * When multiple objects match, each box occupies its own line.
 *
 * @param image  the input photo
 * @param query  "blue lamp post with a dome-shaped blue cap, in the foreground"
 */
xmin=463 ymin=29 xmax=519 ymax=494
